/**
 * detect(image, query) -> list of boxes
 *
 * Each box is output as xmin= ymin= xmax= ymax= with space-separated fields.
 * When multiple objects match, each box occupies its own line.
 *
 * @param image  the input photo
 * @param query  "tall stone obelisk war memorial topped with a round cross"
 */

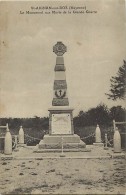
xmin=38 ymin=42 xmax=86 ymax=151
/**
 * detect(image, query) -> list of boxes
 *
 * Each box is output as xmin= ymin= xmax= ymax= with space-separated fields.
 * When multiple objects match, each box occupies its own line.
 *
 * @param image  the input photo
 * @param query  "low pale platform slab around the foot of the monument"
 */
xmin=0 ymin=145 xmax=126 ymax=161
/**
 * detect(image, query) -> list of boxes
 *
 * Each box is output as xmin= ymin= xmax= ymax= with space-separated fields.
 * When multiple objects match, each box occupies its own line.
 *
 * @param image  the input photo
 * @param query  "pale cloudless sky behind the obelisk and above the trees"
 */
xmin=0 ymin=0 xmax=126 ymax=118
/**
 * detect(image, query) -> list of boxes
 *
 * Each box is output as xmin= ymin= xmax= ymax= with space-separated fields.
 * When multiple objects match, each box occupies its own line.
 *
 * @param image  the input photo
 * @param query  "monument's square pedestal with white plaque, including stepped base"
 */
xmin=38 ymin=106 xmax=86 ymax=152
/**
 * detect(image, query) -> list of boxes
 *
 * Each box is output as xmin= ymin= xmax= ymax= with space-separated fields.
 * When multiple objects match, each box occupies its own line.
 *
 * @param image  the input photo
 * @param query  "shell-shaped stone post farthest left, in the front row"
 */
xmin=4 ymin=124 xmax=12 ymax=155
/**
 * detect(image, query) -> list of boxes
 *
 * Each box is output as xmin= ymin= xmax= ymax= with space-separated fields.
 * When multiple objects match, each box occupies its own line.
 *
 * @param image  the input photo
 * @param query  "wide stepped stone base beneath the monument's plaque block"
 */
xmin=36 ymin=134 xmax=89 ymax=152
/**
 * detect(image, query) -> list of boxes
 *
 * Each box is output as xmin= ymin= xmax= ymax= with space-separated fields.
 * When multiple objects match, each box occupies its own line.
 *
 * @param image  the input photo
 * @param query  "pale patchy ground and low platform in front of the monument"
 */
xmin=0 ymin=146 xmax=126 ymax=194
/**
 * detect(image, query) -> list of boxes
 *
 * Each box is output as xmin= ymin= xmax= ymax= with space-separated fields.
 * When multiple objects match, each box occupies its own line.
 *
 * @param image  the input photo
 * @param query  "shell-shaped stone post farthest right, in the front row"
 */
xmin=113 ymin=127 xmax=121 ymax=153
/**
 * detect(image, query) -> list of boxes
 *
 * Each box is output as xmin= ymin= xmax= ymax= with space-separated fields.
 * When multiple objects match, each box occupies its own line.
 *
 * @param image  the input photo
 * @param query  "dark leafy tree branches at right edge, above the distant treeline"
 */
xmin=106 ymin=60 xmax=126 ymax=100
